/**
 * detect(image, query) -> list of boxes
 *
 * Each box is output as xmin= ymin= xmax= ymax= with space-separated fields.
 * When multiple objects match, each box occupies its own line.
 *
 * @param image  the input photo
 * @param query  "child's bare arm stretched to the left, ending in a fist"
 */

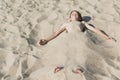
xmin=39 ymin=27 xmax=66 ymax=45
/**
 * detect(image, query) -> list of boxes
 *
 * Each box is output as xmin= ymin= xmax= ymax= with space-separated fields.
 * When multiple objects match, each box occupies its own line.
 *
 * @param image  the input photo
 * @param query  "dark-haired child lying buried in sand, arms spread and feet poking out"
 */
xmin=39 ymin=10 xmax=112 ymax=73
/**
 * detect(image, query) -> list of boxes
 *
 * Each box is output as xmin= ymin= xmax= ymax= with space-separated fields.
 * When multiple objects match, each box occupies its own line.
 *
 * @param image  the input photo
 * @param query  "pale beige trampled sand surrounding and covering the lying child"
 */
xmin=0 ymin=0 xmax=120 ymax=80
